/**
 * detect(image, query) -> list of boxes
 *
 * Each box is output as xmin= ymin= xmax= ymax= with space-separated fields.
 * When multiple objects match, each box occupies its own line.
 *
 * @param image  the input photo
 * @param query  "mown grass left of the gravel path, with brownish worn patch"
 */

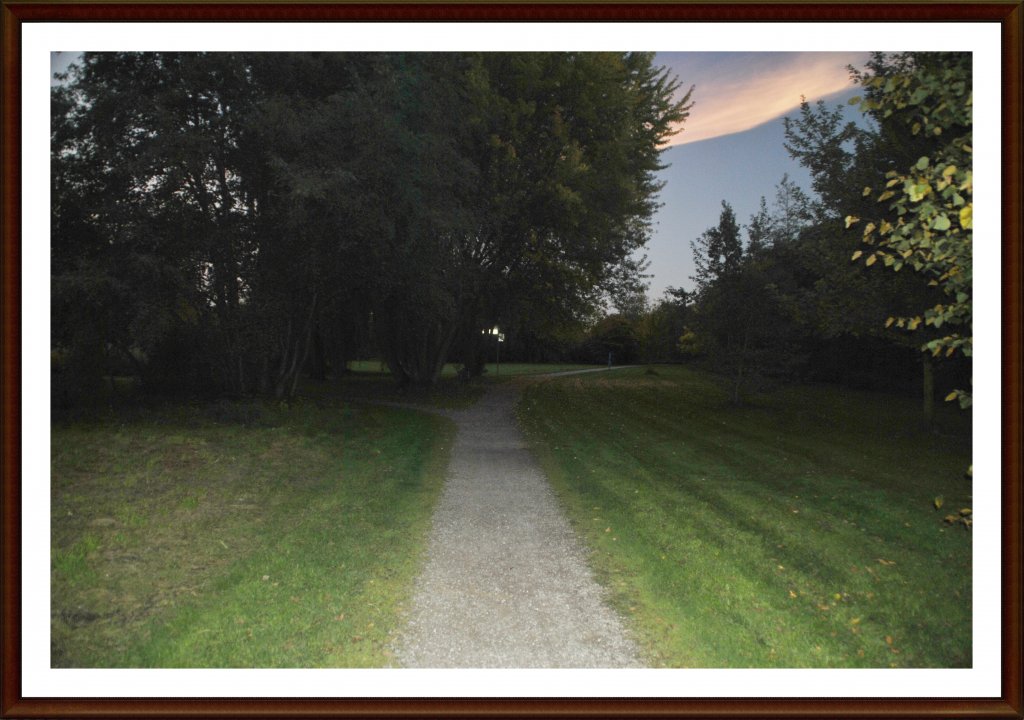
xmin=51 ymin=398 xmax=454 ymax=668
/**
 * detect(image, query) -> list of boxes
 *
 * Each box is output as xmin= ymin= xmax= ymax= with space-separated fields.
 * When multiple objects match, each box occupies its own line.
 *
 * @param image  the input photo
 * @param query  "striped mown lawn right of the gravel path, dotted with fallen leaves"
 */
xmin=517 ymin=367 xmax=972 ymax=668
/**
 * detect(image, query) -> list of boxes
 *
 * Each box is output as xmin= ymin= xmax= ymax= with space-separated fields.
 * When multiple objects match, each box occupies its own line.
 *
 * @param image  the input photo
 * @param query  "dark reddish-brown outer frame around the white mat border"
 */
xmin=0 ymin=0 xmax=1024 ymax=718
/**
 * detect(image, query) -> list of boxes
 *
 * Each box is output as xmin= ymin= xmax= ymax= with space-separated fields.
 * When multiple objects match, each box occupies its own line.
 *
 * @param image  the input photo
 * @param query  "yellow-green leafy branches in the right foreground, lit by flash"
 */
xmin=847 ymin=53 xmax=973 ymax=408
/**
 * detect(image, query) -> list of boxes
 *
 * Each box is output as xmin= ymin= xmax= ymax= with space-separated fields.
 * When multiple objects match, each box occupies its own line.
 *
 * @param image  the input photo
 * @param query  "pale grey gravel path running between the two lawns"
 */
xmin=395 ymin=376 xmax=640 ymax=668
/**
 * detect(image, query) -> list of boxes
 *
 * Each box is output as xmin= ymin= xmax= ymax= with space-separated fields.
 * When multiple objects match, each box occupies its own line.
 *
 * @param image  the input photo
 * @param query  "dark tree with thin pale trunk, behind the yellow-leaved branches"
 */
xmin=785 ymin=59 xmax=963 ymax=423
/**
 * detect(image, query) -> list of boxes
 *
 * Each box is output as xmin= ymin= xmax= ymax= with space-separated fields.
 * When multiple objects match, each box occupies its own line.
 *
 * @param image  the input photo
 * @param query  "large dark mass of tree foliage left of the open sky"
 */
xmin=51 ymin=52 xmax=689 ymax=397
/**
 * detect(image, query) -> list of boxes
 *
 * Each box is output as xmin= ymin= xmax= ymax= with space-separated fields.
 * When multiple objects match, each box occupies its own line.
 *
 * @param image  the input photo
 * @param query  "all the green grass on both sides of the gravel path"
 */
xmin=50 ymin=364 xmax=972 ymax=668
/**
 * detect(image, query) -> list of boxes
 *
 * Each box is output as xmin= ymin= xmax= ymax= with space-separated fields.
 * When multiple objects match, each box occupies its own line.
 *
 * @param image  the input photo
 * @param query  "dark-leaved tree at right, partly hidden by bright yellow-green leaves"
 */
xmin=786 ymin=60 xmax=962 ymax=424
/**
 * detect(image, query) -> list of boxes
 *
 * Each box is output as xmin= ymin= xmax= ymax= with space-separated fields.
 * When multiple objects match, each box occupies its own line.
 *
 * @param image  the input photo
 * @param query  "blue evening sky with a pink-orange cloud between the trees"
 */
xmin=646 ymin=52 xmax=868 ymax=300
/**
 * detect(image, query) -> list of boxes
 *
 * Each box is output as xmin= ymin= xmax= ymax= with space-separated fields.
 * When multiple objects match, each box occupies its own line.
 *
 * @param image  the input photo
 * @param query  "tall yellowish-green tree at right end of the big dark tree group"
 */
xmin=452 ymin=53 xmax=690 ymax=383
